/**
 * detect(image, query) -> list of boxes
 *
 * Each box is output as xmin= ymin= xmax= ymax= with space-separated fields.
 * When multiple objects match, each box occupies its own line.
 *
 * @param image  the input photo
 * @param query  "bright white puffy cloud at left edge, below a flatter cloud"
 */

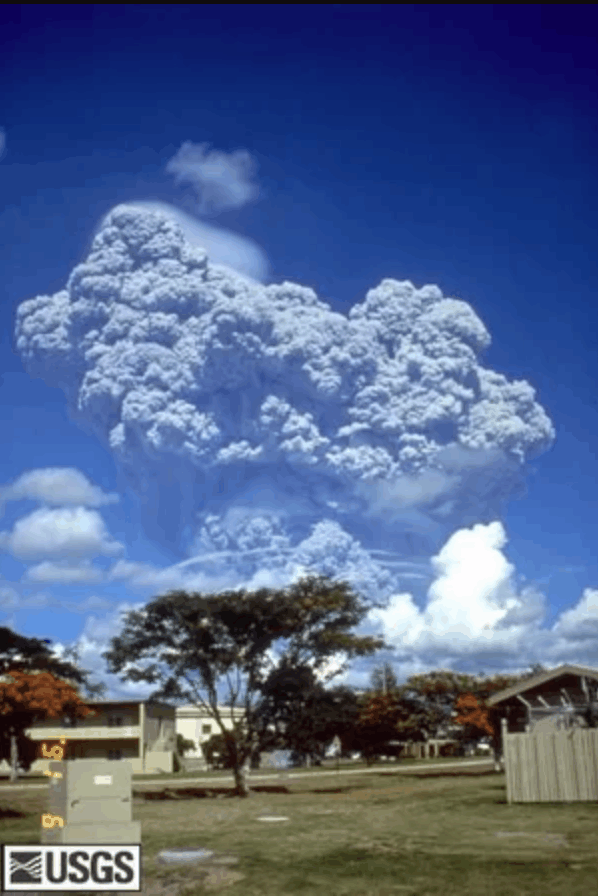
xmin=0 ymin=507 xmax=123 ymax=562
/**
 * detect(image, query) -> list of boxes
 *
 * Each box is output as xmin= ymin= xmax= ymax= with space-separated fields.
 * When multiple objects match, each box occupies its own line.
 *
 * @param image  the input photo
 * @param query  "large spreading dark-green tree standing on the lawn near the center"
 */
xmin=103 ymin=576 xmax=387 ymax=796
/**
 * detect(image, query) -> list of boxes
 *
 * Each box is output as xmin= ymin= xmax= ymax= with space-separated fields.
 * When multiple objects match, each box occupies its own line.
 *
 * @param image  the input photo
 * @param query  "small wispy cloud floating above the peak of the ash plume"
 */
xmin=166 ymin=141 xmax=260 ymax=215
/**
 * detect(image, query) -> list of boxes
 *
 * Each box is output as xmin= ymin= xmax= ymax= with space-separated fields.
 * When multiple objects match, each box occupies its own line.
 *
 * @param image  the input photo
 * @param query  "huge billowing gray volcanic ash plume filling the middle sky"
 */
xmin=17 ymin=205 xmax=554 ymax=598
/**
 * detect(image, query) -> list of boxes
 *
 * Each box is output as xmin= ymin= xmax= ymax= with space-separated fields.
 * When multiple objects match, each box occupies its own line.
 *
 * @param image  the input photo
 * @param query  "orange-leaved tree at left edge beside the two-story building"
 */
xmin=0 ymin=669 xmax=97 ymax=781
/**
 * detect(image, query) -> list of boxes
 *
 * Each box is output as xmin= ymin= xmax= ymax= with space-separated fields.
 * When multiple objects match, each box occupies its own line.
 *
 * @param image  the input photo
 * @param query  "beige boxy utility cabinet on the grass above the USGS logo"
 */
xmin=41 ymin=759 xmax=141 ymax=845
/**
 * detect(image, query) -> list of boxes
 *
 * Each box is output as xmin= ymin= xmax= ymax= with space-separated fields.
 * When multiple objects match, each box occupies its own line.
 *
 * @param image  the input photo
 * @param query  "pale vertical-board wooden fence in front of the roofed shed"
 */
xmin=503 ymin=728 xmax=598 ymax=803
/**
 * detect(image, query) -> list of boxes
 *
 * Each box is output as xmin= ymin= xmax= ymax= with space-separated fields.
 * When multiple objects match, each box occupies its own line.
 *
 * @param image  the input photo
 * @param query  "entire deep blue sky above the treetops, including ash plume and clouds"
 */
xmin=0 ymin=4 xmax=598 ymax=699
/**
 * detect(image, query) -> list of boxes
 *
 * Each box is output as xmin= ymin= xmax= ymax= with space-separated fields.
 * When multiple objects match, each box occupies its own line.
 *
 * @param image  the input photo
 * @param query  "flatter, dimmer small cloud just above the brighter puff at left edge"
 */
xmin=0 ymin=467 xmax=120 ymax=507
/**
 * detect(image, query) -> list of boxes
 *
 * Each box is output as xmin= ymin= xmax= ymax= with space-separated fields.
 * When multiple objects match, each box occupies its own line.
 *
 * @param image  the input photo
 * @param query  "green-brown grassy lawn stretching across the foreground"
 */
xmin=0 ymin=762 xmax=598 ymax=896
